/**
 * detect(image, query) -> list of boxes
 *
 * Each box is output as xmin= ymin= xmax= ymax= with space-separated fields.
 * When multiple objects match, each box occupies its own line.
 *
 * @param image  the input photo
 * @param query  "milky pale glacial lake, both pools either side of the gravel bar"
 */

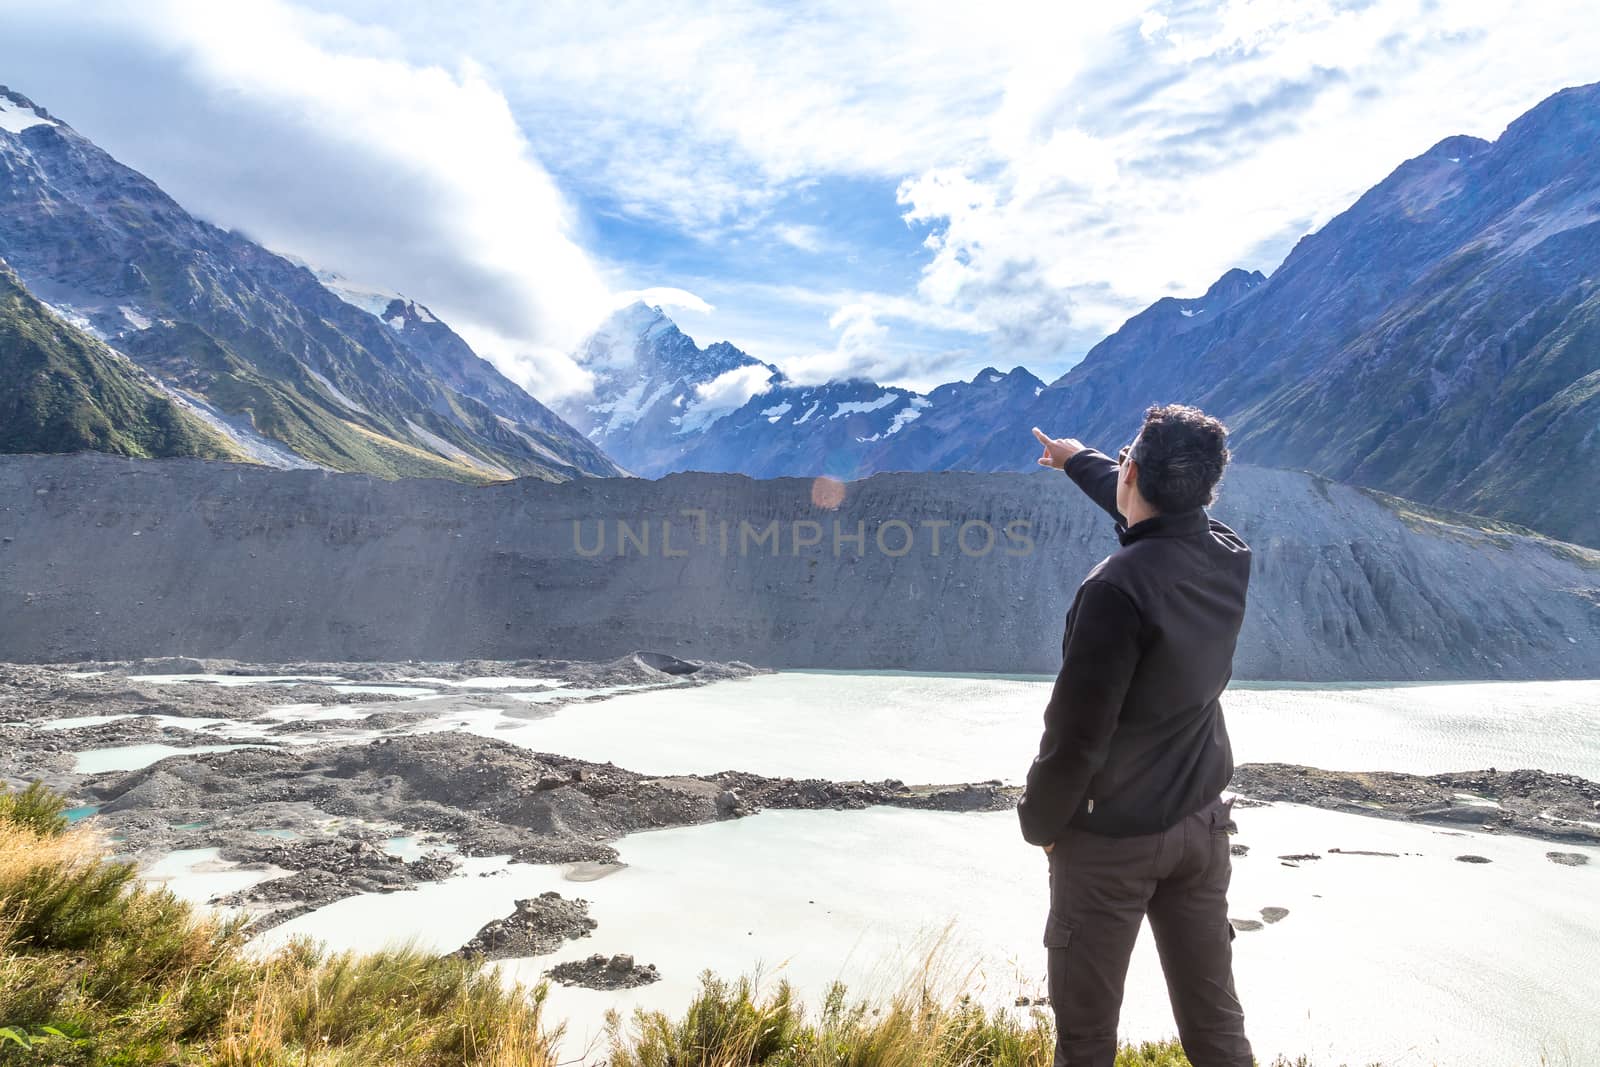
xmin=140 ymin=672 xmax=1600 ymax=1067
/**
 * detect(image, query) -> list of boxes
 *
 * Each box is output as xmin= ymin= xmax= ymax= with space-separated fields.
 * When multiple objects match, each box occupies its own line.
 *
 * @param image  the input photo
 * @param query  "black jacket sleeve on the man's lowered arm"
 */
xmin=1016 ymin=577 xmax=1141 ymax=845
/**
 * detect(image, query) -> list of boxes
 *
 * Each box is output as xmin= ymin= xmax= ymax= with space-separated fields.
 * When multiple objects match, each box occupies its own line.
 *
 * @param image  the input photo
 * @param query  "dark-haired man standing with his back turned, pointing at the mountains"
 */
xmin=1018 ymin=405 xmax=1253 ymax=1067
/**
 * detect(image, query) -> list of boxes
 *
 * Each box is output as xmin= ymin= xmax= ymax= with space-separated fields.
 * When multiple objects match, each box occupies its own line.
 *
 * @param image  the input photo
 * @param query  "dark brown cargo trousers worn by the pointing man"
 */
xmin=1045 ymin=798 xmax=1253 ymax=1067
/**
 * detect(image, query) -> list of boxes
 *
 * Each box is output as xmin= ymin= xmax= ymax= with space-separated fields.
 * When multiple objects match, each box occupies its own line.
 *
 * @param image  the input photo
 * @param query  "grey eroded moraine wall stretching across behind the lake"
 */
xmin=0 ymin=454 xmax=1600 ymax=680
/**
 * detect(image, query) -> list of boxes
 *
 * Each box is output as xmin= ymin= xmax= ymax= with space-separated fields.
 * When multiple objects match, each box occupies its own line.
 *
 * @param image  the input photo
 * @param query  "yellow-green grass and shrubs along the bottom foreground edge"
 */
xmin=0 ymin=787 xmax=1324 ymax=1067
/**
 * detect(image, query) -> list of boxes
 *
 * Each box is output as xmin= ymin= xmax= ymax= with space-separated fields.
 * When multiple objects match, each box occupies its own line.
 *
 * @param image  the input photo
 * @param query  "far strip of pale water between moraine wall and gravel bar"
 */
xmin=458 ymin=672 xmax=1600 ymax=782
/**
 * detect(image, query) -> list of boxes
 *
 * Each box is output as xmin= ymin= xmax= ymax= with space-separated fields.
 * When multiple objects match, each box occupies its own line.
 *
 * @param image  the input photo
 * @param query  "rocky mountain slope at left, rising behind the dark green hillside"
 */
xmin=0 ymin=88 xmax=619 ymax=482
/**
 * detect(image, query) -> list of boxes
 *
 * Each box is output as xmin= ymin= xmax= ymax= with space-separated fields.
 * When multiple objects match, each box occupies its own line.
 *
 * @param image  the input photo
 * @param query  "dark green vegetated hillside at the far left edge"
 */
xmin=0 ymin=264 xmax=240 ymax=459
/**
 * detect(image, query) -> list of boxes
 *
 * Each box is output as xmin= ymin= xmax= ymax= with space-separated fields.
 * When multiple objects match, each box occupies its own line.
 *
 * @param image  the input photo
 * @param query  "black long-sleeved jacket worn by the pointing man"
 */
xmin=1018 ymin=448 xmax=1250 ymax=845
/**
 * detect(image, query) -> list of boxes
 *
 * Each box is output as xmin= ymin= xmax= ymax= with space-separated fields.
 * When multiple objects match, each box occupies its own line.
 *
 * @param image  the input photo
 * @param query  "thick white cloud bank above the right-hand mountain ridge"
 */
xmin=898 ymin=0 xmax=1600 ymax=362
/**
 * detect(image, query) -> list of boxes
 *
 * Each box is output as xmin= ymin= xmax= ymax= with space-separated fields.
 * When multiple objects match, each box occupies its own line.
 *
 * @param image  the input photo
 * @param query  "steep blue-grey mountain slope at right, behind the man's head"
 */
xmin=955 ymin=86 xmax=1600 ymax=544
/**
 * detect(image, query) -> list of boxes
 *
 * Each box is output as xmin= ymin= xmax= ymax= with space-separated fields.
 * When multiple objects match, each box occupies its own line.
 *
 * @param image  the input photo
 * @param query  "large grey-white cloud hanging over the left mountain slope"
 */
xmin=0 ymin=0 xmax=610 ymax=392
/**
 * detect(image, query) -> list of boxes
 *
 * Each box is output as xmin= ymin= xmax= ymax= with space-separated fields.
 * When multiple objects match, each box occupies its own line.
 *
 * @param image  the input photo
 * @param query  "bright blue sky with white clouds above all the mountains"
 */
xmin=0 ymin=0 xmax=1600 ymax=398
